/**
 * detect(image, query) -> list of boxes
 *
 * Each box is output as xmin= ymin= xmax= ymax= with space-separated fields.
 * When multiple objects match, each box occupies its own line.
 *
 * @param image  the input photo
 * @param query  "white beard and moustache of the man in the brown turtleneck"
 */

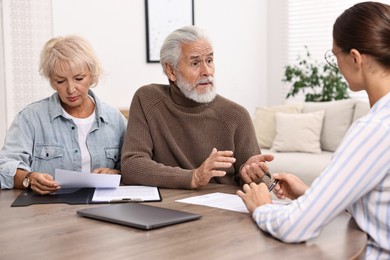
xmin=176 ymin=74 xmax=217 ymax=103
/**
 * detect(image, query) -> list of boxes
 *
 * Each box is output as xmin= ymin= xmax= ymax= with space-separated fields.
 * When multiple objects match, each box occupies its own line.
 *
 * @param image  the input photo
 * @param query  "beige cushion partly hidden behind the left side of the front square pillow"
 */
xmin=253 ymin=103 xmax=303 ymax=148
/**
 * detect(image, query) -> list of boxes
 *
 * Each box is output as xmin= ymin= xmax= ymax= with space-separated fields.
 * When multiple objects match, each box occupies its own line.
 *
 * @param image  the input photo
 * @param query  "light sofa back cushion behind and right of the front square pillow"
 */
xmin=303 ymin=99 xmax=355 ymax=152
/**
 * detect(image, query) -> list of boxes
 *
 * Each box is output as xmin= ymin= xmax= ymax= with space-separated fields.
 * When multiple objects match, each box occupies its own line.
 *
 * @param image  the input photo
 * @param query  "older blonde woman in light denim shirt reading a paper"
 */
xmin=0 ymin=36 xmax=126 ymax=194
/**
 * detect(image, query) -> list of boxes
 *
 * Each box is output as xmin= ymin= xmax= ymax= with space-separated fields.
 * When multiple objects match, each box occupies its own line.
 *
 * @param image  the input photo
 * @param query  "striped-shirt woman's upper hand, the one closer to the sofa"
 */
xmin=273 ymin=173 xmax=308 ymax=200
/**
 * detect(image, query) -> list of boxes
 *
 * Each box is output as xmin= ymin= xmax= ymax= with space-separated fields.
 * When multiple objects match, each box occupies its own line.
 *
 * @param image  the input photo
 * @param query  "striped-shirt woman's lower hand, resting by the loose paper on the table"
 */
xmin=237 ymin=182 xmax=272 ymax=215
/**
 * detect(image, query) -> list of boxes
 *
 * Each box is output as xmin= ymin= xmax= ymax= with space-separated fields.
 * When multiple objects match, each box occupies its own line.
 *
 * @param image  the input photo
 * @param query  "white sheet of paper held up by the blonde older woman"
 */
xmin=55 ymin=169 xmax=121 ymax=188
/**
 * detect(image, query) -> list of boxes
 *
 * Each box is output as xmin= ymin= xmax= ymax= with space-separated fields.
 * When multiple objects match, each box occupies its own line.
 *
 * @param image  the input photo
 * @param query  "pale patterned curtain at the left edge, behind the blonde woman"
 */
xmin=0 ymin=0 xmax=53 ymax=143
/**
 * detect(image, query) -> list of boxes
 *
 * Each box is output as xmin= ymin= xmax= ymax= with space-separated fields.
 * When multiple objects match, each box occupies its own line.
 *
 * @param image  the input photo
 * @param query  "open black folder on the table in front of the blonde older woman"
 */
xmin=11 ymin=186 xmax=162 ymax=207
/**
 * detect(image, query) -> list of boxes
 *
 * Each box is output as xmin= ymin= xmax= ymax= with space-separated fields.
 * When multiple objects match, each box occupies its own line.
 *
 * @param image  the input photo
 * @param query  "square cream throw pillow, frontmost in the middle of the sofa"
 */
xmin=271 ymin=110 xmax=325 ymax=153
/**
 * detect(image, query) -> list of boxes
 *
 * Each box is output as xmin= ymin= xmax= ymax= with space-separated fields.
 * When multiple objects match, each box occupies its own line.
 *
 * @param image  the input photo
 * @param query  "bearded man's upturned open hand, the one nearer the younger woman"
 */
xmin=240 ymin=154 xmax=274 ymax=183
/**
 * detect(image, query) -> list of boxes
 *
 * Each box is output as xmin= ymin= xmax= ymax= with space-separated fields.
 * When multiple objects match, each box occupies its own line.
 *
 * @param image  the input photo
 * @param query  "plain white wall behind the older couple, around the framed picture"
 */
xmin=52 ymin=0 xmax=267 ymax=114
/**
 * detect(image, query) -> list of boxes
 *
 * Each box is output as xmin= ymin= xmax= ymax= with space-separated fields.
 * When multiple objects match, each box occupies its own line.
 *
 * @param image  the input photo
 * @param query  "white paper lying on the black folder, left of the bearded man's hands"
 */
xmin=92 ymin=186 xmax=161 ymax=202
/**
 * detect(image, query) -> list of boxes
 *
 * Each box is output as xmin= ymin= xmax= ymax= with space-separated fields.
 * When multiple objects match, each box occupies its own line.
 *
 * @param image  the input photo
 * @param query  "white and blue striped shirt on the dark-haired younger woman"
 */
xmin=252 ymin=93 xmax=390 ymax=259
